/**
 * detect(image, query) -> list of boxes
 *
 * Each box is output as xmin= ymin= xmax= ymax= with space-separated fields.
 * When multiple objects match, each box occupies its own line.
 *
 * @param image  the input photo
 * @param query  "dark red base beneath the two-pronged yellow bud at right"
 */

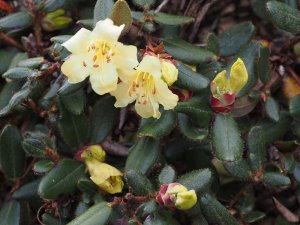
xmin=210 ymin=94 xmax=236 ymax=113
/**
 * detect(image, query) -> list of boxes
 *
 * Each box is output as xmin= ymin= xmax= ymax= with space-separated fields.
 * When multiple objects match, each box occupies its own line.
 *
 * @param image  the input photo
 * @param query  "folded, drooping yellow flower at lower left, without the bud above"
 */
xmin=85 ymin=159 xmax=124 ymax=194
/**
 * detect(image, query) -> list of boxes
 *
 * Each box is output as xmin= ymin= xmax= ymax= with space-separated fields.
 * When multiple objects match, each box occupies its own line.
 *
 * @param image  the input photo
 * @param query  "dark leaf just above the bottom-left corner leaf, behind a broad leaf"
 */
xmin=13 ymin=179 xmax=41 ymax=200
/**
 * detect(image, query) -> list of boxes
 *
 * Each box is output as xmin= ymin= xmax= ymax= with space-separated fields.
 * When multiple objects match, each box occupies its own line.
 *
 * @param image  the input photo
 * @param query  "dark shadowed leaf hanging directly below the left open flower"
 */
xmin=90 ymin=96 xmax=119 ymax=144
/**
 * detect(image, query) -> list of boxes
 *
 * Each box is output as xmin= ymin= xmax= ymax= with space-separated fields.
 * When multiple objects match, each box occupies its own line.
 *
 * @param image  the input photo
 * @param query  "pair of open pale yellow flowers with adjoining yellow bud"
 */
xmin=61 ymin=19 xmax=178 ymax=118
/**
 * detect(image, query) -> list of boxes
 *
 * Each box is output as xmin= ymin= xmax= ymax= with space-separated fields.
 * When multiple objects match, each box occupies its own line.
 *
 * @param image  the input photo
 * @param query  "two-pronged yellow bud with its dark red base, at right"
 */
xmin=210 ymin=58 xmax=248 ymax=113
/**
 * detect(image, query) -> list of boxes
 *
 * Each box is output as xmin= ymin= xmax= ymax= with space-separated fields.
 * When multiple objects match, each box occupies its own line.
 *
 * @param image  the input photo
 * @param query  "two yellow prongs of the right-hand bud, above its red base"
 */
xmin=211 ymin=58 xmax=248 ymax=98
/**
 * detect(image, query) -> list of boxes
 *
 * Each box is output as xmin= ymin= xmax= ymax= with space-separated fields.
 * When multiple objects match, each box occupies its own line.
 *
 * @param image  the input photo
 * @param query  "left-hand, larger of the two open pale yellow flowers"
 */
xmin=61 ymin=19 xmax=138 ymax=95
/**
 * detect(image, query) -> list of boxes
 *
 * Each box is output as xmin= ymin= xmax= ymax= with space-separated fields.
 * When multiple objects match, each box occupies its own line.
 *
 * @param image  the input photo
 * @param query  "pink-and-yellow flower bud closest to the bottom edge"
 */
xmin=156 ymin=183 xmax=197 ymax=210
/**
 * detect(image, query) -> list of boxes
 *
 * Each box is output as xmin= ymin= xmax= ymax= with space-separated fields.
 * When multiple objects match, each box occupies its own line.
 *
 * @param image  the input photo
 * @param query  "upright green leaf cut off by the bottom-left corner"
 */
xmin=0 ymin=200 xmax=21 ymax=225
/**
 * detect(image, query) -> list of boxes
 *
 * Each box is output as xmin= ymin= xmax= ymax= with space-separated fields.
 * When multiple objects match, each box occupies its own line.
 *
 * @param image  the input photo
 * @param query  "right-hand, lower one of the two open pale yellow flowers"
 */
xmin=111 ymin=55 xmax=178 ymax=118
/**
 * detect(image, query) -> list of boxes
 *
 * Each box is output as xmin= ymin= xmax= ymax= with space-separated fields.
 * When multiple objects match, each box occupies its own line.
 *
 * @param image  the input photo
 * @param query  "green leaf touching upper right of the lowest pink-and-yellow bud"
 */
xmin=177 ymin=169 xmax=213 ymax=193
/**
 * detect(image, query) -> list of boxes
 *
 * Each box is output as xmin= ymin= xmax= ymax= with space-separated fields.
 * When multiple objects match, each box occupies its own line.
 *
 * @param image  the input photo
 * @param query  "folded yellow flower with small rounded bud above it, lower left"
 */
xmin=79 ymin=145 xmax=124 ymax=194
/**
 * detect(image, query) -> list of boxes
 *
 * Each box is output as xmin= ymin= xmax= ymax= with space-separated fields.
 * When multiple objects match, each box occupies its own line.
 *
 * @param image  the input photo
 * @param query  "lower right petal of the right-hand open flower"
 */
xmin=155 ymin=79 xmax=178 ymax=110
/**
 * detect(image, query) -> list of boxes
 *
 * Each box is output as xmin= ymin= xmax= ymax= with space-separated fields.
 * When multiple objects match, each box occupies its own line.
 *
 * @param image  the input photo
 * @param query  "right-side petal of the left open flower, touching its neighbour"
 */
xmin=112 ymin=42 xmax=139 ymax=81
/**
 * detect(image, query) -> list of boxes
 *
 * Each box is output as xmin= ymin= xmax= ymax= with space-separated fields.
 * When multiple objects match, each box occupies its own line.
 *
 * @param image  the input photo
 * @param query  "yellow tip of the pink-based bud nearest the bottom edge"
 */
xmin=175 ymin=190 xmax=197 ymax=210
